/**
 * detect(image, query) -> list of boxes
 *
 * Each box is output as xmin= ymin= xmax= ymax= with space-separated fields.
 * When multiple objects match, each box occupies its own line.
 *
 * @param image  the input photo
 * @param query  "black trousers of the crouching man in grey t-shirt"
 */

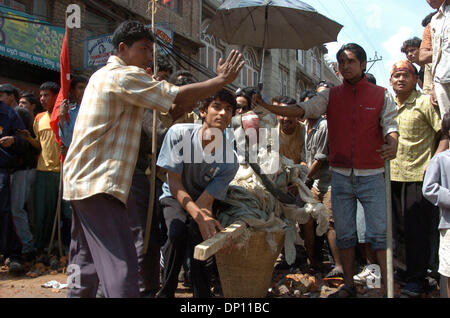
xmin=158 ymin=197 xmax=212 ymax=298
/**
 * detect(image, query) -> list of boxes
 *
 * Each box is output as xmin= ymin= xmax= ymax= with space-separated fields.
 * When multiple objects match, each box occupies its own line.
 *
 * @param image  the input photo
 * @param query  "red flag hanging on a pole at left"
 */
xmin=50 ymin=26 xmax=70 ymax=161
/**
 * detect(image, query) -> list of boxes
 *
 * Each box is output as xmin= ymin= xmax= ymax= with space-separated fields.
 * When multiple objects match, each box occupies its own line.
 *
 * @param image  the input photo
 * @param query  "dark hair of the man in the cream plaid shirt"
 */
xmin=112 ymin=20 xmax=155 ymax=50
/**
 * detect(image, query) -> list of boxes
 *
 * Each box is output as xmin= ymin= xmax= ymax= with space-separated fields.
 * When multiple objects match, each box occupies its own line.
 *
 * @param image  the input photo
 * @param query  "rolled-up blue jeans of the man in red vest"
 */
xmin=331 ymin=171 xmax=386 ymax=250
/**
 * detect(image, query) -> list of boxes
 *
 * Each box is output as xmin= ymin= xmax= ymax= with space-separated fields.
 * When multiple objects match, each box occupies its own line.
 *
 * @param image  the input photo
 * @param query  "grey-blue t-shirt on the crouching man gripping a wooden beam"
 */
xmin=157 ymin=124 xmax=239 ymax=201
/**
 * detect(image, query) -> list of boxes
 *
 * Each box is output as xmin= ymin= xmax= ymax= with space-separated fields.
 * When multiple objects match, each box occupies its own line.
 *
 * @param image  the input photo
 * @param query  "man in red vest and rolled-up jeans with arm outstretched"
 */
xmin=255 ymin=43 xmax=398 ymax=298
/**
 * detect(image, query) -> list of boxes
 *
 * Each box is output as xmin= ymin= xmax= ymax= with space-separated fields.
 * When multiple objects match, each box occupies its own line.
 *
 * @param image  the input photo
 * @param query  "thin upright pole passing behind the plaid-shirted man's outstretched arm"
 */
xmin=144 ymin=0 xmax=158 ymax=254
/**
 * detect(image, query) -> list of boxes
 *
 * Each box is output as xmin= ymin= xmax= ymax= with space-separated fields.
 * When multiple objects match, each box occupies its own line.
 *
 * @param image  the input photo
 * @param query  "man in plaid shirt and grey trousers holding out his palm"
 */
xmin=64 ymin=21 xmax=244 ymax=297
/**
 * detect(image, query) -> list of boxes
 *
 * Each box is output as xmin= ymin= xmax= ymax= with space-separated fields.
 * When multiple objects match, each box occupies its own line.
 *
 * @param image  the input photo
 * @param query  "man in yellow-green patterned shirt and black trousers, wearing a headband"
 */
xmin=390 ymin=61 xmax=448 ymax=297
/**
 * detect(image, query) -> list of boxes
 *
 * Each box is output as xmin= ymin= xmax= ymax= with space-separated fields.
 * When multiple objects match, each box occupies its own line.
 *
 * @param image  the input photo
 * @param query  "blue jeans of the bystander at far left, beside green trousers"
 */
xmin=11 ymin=169 xmax=36 ymax=253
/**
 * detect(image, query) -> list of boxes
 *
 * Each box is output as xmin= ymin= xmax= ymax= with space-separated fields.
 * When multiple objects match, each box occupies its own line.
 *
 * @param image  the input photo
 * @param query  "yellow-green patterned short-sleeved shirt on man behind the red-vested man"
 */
xmin=391 ymin=91 xmax=441 ymax=182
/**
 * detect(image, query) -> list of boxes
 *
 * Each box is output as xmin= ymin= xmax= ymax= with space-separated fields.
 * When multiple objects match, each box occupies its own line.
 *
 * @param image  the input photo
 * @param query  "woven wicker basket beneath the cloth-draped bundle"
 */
xmin=216 ymin=231 xmax=285 ymax=298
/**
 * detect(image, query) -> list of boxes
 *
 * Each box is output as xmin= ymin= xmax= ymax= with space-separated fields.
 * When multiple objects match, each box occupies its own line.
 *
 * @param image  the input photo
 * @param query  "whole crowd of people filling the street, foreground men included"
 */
xmin=0 ymin=0 xmax=450 ymax=298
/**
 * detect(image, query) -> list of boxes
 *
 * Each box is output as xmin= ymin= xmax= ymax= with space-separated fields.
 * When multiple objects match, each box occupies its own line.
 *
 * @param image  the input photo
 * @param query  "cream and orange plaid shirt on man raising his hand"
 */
xmin=63 ymin=55 xmax=178 ymax=204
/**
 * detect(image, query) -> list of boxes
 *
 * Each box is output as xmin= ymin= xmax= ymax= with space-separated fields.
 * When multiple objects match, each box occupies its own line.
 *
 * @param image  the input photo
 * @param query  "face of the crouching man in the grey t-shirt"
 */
xmin=200 ymin=98 xmax=233 ymax=131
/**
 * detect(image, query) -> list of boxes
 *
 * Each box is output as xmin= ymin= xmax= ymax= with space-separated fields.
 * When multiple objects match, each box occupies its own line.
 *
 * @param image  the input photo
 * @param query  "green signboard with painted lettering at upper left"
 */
xmin=0 ymin=6 xmax=65 ymax=72
